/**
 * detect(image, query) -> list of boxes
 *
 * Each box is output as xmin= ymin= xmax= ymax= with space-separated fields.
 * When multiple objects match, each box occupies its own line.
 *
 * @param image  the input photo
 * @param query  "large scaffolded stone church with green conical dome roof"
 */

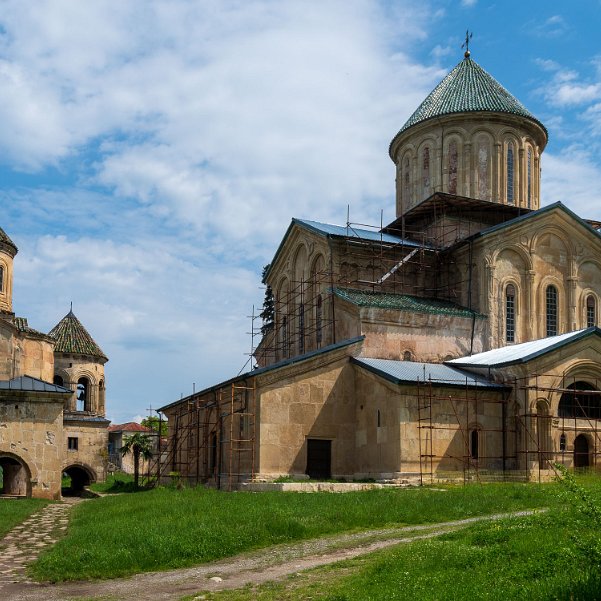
xmin=160 ymin=52 xmax=601 ymax=488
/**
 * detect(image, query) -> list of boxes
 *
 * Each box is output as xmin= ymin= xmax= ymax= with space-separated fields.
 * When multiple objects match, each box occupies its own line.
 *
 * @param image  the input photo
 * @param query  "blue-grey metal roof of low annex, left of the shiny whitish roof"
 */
xmin=352 ymin=357 xmax=505 ymax=390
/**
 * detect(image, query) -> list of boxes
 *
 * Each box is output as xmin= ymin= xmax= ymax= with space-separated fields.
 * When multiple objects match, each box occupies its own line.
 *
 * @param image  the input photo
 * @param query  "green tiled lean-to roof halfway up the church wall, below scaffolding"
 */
xmin=334 ymin=288 xmax=484 ymax=318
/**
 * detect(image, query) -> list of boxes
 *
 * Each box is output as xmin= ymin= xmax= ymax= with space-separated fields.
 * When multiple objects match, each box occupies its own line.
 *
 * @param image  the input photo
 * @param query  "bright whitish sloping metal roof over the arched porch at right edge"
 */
xmin=445 ymin=327 xmax=601 ymax=367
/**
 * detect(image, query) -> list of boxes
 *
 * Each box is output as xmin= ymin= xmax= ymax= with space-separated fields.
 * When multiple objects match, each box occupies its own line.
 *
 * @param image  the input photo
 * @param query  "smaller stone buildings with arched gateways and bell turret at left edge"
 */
xmin=0 ymin=229 xmax=110 ymax=499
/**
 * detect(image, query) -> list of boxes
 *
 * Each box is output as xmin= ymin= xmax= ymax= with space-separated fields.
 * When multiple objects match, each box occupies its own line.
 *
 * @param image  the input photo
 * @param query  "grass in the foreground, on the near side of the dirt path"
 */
xmin=193 ymin=509 xmax=601 ymax=601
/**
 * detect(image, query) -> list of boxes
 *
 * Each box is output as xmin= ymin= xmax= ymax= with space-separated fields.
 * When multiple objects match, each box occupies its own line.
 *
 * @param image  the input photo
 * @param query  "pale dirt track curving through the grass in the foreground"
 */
xmin=0 ymin=510 xmax=541 ymax=601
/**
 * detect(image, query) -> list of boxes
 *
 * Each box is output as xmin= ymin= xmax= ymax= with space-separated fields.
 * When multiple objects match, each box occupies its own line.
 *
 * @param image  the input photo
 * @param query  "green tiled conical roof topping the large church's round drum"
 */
xmin=395 ymin=56 xmax=547 ymax=144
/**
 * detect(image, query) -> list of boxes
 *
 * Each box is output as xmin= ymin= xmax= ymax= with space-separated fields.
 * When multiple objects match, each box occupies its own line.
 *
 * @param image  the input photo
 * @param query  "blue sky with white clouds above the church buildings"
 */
xmin=0 ymin=0 xmax=601 ymax=422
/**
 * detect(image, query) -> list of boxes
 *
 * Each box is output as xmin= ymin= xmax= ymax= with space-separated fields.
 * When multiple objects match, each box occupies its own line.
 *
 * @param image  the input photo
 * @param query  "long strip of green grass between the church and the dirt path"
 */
xmin=32 ymin=484 xmax=558 ymax=581
